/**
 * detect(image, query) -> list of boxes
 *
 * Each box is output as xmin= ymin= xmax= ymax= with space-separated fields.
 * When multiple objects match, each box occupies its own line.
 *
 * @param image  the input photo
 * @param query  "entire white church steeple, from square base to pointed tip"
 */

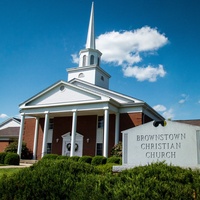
xmin=67 ymin=2 xmax=111 ymax=89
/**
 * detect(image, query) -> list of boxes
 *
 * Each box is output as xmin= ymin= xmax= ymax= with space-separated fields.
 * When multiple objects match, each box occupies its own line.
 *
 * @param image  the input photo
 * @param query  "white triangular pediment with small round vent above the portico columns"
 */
xmin=25 ymin=81 xmax=101 ymax=106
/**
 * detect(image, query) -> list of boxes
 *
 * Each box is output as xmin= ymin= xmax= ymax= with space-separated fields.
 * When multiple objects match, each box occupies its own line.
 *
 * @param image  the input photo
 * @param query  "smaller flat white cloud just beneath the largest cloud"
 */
xmin=123 ymin=65 xmax=166 ymax=82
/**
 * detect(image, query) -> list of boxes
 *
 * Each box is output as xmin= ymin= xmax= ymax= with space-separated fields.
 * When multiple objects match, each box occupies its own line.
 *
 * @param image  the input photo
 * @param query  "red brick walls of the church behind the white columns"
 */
xmin=23 ymin=113 xmax=151 ymax=159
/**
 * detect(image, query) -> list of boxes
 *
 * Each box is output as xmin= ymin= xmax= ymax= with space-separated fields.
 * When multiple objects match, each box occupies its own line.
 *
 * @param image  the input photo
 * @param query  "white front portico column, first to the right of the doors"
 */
xmin=103 ymin=108 xmax=109 ymax=157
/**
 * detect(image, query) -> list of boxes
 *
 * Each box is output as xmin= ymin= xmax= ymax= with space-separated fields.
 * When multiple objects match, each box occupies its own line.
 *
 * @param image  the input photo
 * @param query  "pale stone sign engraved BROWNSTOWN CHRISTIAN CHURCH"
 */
xmin=122 ymin=121 xmax=200 ymax=167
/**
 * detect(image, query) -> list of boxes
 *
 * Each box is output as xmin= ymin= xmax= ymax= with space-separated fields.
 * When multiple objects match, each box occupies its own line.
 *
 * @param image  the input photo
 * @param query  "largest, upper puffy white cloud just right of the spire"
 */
xmin=96 ymin=26 xmax=168 ymax=65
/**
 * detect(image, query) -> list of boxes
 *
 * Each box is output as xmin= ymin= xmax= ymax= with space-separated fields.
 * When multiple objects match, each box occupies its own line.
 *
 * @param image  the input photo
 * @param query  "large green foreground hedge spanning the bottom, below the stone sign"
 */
xmin=0 ymin=162 xmax=200 ymax=200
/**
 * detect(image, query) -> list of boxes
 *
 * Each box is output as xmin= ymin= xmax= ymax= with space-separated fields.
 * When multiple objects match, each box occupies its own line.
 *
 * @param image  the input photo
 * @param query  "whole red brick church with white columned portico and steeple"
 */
xmin=18 ymin=4 xmax=164 ymax=159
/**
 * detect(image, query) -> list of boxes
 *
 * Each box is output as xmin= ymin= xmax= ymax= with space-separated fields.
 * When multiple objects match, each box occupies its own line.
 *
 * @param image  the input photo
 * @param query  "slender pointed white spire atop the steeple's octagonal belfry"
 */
xmin=86 ymin=2 xmax=95 ymax=49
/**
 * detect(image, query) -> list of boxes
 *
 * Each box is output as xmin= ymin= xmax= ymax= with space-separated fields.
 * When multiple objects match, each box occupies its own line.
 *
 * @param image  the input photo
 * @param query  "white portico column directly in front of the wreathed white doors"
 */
xmin=70 ymin=110 xmax=77 ymax=156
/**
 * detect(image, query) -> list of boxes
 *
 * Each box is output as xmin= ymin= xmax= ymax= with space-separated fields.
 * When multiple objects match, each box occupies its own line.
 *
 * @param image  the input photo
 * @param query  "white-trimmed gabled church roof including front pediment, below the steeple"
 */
xmin=20 ymin=78 xmax=164 ymax=120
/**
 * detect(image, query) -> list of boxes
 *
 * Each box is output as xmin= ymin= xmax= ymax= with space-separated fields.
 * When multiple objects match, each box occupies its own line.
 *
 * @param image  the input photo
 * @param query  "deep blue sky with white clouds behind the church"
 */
xmin=0 ymin=0 xmax=200 ymax=122
